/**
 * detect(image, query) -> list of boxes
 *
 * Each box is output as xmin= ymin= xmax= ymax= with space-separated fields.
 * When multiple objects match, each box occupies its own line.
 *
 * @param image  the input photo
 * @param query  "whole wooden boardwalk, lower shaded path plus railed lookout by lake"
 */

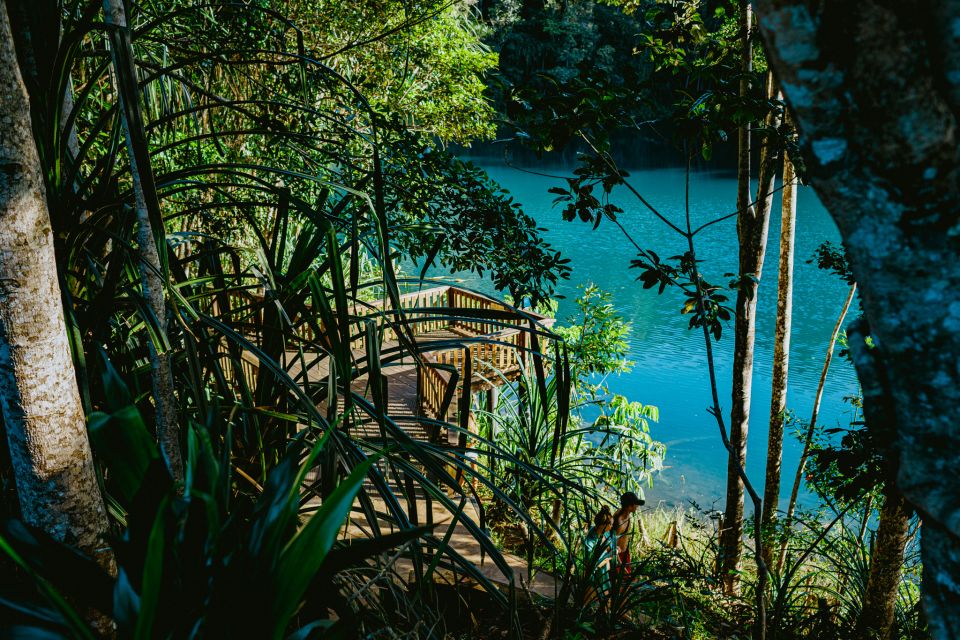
xmin=236 ymin=287 xmax=556 ymax=597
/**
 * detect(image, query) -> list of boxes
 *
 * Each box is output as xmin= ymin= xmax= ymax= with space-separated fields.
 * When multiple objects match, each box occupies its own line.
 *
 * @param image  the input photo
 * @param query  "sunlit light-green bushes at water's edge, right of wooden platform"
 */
xmin=478 ymin=285 xmax=666 ymax=544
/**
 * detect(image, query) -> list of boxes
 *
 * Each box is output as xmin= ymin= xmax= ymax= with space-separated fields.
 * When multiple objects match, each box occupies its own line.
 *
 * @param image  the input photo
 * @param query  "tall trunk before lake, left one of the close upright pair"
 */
xmin=720 ymin=63 xmax=780 ymax=593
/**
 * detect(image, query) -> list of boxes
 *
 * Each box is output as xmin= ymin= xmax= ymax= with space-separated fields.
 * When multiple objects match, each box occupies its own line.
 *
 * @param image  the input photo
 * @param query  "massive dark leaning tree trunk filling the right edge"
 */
xmin=759 ymin=5 xmax=960 ymax=638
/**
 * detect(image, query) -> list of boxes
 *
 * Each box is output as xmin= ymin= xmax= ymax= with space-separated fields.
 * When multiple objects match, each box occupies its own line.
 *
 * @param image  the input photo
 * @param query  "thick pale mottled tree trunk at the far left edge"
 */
xmin=0 ymin=4 xmax=110 ymax=565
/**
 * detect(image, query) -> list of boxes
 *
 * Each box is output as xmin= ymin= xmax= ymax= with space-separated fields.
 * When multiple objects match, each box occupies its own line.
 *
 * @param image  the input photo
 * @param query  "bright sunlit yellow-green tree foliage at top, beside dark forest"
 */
xmin=272 ymin=0 xmax=497 ymax=143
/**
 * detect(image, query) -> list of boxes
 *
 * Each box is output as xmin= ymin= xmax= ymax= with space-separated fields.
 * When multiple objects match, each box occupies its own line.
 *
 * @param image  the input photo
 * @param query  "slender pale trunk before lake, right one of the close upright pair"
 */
xmin=760 ymin=142 xmax=797 ymax=567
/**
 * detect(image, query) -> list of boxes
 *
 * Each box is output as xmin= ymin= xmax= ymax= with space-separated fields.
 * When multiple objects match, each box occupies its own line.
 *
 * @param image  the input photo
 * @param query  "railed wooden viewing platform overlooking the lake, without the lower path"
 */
xmin=231 ymin=285 xmax=554 ymax=438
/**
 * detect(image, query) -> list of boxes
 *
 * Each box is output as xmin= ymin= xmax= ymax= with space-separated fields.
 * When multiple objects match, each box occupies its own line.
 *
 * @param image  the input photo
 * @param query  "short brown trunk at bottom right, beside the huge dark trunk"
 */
xmin=857 ymin=488 xmax=910 ymax=640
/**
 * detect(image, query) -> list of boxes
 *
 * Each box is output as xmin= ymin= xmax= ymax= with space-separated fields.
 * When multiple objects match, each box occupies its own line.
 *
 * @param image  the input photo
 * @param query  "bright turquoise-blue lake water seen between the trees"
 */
xmin=424 ymin=160 xmax=857 ymax=509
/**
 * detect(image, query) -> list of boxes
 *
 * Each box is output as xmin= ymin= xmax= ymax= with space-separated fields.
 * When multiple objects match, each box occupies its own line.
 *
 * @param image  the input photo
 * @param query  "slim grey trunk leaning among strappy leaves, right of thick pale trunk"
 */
xmin=103 ymin=0 xmax=183 ymax=482
